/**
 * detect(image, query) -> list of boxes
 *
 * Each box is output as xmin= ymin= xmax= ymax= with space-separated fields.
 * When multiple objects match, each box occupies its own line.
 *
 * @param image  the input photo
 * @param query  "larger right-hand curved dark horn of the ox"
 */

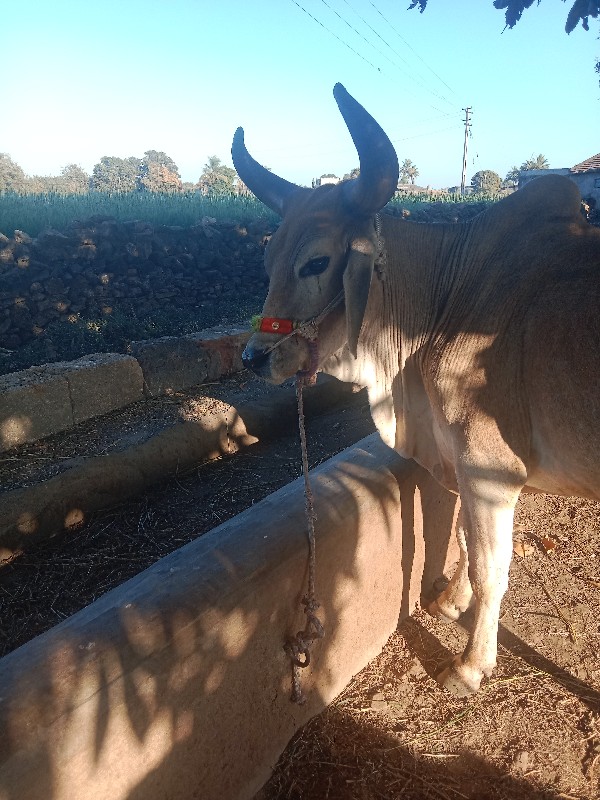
xmin=333 ymin=83 xmax=399 ymax=215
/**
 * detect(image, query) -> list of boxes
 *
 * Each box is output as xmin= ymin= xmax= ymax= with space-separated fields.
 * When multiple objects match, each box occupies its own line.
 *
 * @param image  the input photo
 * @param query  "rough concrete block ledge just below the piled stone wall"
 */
xmin=0 ymin=327 xmax=250 ymax=452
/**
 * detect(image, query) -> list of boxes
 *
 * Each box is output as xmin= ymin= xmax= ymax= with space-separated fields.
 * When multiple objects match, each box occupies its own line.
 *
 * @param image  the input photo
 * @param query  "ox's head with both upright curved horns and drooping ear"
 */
xmin=231 ymin=83 xmax=398 ymax=383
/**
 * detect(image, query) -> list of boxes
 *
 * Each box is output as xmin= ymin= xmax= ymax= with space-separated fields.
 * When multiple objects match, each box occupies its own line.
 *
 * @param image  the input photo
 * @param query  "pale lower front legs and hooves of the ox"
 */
xmin=437 ymin=487 xmax=518 ymax=697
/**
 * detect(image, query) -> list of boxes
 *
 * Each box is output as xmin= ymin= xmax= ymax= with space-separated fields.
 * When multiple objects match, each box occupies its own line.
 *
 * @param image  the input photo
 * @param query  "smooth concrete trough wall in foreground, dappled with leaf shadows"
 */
xmin=0 ymin=436 xmax=455 ymax=800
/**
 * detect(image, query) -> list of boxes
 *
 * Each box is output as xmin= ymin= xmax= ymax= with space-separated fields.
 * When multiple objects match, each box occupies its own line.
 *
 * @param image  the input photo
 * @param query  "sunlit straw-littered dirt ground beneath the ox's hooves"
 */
xmin=256 ymin=495 xmax=600 ymax=800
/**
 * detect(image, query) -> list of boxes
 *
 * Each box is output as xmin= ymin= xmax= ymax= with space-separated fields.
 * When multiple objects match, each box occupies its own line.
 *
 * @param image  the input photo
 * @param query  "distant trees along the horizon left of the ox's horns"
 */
xmin=0 ymin=150 xmax=239 ymax=195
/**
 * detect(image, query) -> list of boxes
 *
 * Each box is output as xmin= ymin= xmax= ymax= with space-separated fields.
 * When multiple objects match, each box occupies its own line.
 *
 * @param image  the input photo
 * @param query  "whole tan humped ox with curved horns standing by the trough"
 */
xmin=232 ymin=84 xmax=600 ymax=695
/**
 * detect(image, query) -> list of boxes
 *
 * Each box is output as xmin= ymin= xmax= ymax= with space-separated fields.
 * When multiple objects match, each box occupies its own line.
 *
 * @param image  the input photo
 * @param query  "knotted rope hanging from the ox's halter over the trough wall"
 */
xmin=284 ymin=376 xmax=325 ymax=705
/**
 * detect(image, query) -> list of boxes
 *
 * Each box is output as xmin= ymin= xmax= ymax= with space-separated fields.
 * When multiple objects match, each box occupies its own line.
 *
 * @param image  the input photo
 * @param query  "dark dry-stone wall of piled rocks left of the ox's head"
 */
xmin=0 ymin=216 xmax=271 ymax=350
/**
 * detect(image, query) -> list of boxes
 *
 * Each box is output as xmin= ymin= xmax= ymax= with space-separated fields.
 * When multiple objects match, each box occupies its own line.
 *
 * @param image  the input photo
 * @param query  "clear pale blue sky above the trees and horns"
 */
xmin=0 ymin=0 xmax=600 ymax=187
